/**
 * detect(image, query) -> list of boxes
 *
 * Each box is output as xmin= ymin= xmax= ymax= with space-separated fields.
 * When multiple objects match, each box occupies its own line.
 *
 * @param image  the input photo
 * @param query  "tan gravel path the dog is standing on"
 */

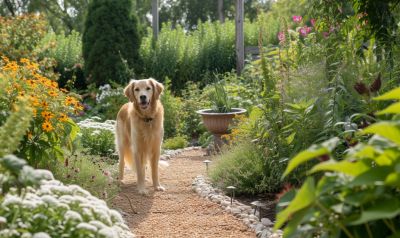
xmin=113 ymin=150 xmax=255 ymax=238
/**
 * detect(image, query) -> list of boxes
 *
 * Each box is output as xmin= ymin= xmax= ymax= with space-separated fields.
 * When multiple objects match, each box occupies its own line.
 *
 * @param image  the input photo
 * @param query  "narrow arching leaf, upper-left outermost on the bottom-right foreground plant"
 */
xmin=283 ymin=137 xmax=339 ymax=177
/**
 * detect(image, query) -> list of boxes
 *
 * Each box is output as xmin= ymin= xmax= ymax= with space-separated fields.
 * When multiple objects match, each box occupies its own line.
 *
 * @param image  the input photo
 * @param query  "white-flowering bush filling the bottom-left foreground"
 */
xmin=0 ymin=156 xmax=133 ymax=237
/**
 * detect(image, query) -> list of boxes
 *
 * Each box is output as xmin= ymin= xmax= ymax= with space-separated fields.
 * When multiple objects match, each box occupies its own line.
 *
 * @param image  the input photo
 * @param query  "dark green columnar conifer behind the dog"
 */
xmin=82 ymin=0 xmax=141 ymax=85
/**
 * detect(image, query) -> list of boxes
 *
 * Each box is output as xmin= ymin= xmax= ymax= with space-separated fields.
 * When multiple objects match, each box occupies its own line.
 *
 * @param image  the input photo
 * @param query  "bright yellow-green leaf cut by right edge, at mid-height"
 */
xmin=363 ymin=121 xmax=400 ymax=145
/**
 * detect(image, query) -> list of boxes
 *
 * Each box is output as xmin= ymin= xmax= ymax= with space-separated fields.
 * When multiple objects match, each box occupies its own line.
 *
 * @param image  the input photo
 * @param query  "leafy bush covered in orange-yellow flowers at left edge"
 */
xmin=0 ymin=57 xmax=82 ymax=166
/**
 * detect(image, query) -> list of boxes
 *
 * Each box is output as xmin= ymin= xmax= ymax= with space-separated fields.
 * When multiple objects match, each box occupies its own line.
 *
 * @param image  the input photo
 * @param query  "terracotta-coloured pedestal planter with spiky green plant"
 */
xmin=197 ymin=81 xmax=246 ymax=150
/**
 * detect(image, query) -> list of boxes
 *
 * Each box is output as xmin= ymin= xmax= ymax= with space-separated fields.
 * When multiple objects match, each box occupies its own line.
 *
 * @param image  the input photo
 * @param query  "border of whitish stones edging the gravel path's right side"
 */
xmin=192 ymin=175 xmax=283 ymax=238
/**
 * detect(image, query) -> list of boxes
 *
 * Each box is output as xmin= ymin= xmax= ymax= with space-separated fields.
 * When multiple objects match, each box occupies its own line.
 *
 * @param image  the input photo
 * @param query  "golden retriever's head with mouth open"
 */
xmin=124 ymin=78 xmax=164 ymax=110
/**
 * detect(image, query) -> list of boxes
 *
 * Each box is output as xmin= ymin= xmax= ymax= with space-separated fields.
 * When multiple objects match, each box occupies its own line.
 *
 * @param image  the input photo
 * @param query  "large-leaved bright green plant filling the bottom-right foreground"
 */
xmin=275 ymin=89 xmax=400 ymax=237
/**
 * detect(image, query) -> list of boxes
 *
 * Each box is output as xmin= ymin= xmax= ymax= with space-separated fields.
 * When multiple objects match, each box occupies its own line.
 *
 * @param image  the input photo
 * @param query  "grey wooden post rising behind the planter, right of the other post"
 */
xmin=235 ymin=0 xmax=244 ymax=75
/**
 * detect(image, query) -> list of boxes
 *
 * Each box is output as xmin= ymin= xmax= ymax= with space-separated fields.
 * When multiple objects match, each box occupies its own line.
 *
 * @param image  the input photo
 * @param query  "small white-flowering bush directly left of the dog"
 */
xmin=78 ymin=117 xmax=117 ymax=159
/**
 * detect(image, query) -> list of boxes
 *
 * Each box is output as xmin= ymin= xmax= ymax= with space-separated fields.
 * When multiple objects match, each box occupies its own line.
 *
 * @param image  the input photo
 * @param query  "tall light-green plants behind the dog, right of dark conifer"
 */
xmin=140 ymin=21 xmax=257 ymax=91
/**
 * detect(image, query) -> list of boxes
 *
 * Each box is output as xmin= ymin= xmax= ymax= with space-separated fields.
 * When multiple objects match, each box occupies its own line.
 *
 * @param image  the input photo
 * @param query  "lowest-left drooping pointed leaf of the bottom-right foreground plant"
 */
xmin=274 ymin=177 xmax=315 ymax=229
